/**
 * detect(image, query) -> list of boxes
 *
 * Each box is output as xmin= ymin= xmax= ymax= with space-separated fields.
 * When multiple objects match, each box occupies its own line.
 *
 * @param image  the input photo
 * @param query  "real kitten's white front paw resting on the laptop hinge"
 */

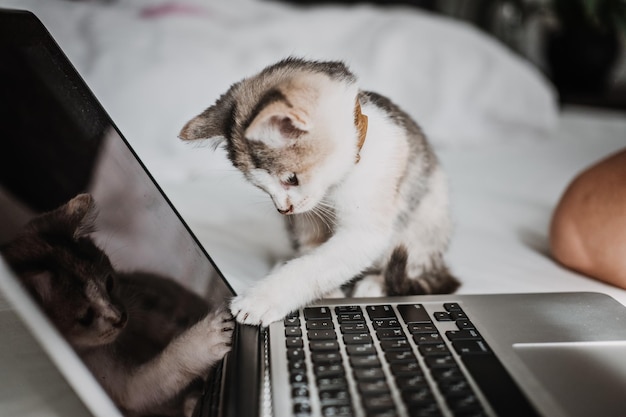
xmin=230 ymin=289 xmax=298 ymax=326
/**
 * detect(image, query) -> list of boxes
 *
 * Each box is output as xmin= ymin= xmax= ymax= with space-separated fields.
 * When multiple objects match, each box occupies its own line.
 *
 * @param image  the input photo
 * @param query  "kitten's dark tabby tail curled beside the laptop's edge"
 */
xmin=384 ymin=246 xmax=461 ymax=296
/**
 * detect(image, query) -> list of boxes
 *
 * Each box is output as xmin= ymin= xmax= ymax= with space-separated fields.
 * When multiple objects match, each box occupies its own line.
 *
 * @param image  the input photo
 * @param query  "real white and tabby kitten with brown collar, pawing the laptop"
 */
xmin=180 ymin=58 xmax=459 ymax=325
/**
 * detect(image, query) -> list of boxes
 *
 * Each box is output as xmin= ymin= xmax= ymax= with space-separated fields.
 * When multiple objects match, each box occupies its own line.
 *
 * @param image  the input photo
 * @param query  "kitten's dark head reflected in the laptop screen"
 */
xmin=3 ymin=194 xmax=126 ymax=347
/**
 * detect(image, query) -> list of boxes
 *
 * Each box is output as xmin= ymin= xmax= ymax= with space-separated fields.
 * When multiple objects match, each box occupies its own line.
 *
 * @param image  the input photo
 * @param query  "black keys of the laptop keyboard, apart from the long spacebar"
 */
xmin=284 ymin=303 xmax=498 ymax=417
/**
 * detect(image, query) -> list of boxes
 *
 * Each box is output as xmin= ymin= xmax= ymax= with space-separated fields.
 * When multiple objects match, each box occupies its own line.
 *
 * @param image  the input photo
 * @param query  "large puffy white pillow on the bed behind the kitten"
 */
xmin=0 ymin=0 xmax=557 ymax=180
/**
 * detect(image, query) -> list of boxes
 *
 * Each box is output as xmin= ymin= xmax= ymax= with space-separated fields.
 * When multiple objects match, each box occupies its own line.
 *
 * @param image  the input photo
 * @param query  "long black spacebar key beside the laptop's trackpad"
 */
xmin=461 ymin=354 xmax=539 ymax=417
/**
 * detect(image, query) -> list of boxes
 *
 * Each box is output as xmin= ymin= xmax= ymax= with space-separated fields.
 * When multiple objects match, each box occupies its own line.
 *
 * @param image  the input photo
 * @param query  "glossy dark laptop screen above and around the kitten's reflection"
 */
xmin=0 ymin=13 xmax=233 ymax=312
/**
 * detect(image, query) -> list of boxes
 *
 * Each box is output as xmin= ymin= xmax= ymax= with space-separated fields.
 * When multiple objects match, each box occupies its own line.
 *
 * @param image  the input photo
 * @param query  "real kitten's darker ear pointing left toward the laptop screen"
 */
xmin=178 ymin=89 xmax=235 ymax=142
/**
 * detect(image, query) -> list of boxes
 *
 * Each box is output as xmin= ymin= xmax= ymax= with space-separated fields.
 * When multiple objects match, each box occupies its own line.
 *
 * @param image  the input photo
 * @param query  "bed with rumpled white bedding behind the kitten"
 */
xmin=0 ymin=0 xmax=626 ymax=304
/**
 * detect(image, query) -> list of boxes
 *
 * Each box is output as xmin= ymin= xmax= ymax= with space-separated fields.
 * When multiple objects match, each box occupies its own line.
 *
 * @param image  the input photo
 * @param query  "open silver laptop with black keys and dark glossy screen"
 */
xmin=0 ymin=10 xmax=626 ymax=417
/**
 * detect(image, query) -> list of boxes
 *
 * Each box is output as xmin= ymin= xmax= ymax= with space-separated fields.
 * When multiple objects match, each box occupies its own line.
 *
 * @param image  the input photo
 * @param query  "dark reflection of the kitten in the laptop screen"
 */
xmin=0 ymin=194 xmax=234 ymax=416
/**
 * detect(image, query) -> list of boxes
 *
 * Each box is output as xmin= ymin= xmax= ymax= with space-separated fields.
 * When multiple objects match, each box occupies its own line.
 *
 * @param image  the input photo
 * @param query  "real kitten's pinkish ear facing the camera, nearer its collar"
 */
xmin=245 ymin=101 xmax=312 ymax=148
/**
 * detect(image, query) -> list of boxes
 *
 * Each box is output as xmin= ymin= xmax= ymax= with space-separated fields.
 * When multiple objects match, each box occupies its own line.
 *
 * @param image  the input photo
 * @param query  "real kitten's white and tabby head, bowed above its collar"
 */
xmin=180 ymin=60 xmax=358 ymax=214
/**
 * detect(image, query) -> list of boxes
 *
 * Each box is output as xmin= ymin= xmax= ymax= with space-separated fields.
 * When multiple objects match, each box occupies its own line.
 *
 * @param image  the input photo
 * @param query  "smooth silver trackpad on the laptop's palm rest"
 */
xmin=513 ymin=341 xmax=626 ymax=417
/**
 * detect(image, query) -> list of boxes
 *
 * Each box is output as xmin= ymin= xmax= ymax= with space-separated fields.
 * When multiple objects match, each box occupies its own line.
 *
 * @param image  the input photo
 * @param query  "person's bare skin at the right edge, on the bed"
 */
xmin=550 ymin=150 xmax=626 ymax=288
